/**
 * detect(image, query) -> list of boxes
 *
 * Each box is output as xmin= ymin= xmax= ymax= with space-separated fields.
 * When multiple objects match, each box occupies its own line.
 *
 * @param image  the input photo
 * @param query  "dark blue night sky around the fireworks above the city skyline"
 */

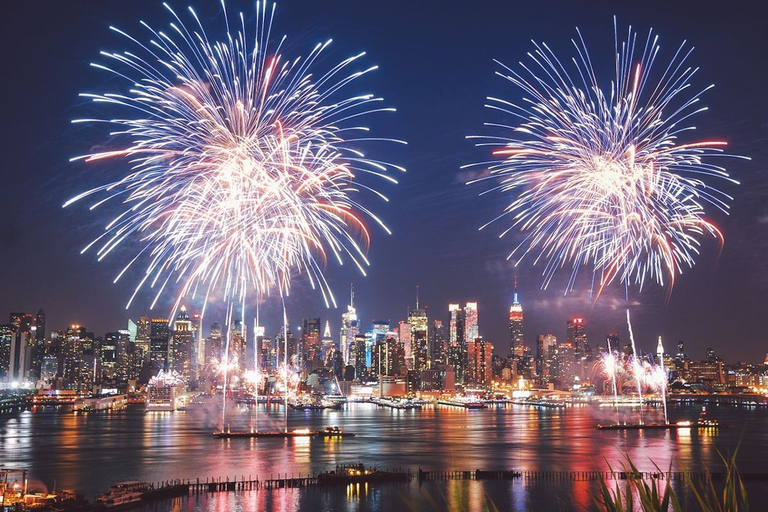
xmin=0 ymin=0 xmax=768 ymax=361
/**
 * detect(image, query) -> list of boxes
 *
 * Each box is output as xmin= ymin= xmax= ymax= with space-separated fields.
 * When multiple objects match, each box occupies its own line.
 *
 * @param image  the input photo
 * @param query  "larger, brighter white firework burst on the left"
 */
xmin=65 ymin=2 xmax=404 ymax=310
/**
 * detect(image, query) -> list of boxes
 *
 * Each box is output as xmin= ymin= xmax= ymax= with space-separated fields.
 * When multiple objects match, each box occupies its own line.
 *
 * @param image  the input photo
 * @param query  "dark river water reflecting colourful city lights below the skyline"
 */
xmin=0 ymin=403 xmax=768 ymax=512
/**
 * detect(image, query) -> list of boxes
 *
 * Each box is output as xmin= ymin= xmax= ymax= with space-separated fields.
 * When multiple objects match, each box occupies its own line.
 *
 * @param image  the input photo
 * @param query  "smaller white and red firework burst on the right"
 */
xmin=468 ymin=19 xmax=736 ymax=291
